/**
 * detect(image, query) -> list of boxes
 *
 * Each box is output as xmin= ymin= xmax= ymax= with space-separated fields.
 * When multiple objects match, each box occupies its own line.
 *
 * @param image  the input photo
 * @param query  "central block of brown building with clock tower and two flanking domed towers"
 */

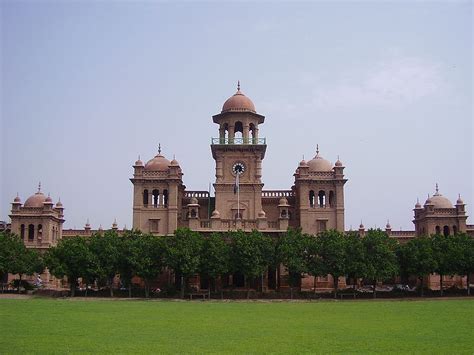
xmin=130 ymin=86 xmax=347 ymax=235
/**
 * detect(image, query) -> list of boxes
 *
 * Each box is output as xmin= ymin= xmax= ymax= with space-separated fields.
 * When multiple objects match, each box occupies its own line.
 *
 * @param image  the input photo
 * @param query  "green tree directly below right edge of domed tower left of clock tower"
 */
xmin=166 ymin=228 xmax=202 ymax=298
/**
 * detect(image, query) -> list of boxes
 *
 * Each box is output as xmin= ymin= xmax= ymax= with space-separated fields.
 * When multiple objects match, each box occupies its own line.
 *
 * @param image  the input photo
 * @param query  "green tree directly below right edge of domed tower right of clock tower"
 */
xmin=316 ymin=230 xmax=346 ymax=298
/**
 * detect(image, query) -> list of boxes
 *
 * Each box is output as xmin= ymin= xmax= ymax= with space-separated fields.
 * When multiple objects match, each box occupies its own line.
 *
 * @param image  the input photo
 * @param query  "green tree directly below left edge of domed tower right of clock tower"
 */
xmin=276 ymin=228 xmax=308 ymax=299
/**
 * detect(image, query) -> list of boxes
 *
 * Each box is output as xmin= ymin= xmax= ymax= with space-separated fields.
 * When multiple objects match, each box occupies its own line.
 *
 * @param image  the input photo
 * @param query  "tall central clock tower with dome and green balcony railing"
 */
xmin=211 ymin=83 xmax=267 ymax=220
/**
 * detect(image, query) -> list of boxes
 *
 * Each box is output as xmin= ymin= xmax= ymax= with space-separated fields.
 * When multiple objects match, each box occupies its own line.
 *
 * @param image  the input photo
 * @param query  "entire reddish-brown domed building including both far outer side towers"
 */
xmin=2 ymin=85 xmax=474 ymax=289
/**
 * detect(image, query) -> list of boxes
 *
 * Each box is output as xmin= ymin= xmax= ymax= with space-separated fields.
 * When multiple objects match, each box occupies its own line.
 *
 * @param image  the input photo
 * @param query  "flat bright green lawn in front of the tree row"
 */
xmin=0 ymin=299 xmax=474 ymax=354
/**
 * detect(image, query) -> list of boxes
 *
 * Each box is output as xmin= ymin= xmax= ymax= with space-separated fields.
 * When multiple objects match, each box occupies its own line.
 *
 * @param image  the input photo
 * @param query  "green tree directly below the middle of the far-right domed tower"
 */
xmin=431 ymin=234 xmax=457 ymax=296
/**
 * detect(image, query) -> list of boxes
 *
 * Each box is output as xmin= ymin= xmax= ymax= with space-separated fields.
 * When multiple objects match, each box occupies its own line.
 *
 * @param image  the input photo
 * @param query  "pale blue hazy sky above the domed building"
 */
xmin=0 ymin=1 xmax=474 ymax=230
